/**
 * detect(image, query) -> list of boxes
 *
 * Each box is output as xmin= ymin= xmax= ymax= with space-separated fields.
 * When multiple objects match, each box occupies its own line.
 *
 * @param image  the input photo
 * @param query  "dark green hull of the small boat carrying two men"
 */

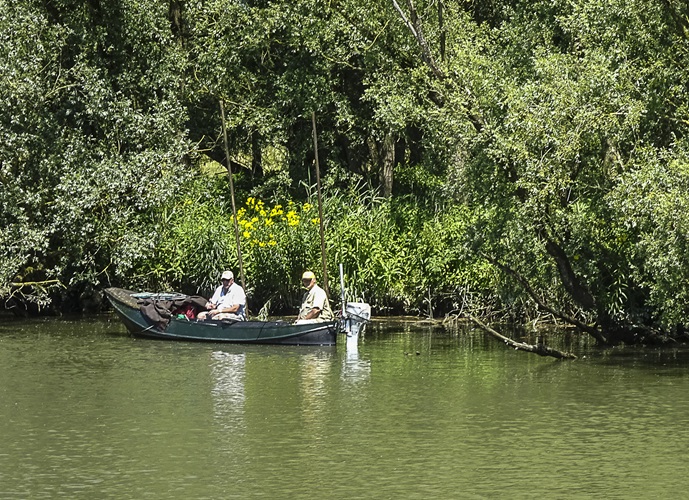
xmin=105 ymin=288 xmax=340 ymax=345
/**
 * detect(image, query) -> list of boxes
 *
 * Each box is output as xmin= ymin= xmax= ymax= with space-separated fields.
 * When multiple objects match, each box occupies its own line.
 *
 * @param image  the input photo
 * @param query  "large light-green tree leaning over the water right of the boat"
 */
xmin=390 ymin=1 xmax=687 ymax=343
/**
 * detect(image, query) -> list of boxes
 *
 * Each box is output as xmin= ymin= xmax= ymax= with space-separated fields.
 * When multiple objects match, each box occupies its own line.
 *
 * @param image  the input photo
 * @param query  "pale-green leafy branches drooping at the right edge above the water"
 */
xmin=609 ymin=141 xmax=689 ymax=328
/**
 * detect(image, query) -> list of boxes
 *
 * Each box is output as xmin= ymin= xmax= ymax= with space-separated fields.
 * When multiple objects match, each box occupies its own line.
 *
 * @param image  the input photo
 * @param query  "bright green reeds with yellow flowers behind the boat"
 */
xmin=127 ymin=179 xmax=506 ymax=315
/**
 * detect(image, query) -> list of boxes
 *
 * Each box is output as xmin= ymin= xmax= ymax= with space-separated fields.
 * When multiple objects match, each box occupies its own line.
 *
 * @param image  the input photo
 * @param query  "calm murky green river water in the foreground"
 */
xmin=0 ymin=317 xmax=689 ymax=499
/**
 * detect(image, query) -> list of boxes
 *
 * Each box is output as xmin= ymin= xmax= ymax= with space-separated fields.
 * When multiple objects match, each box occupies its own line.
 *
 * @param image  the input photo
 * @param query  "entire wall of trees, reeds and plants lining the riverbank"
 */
xmin=0 ymin=0 xmax=689 ymax=345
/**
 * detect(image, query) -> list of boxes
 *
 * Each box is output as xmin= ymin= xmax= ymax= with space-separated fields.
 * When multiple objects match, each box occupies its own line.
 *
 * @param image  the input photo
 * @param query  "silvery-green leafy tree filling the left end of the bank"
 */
xmin=0 ymin=2 xmax=190 ymax=308
